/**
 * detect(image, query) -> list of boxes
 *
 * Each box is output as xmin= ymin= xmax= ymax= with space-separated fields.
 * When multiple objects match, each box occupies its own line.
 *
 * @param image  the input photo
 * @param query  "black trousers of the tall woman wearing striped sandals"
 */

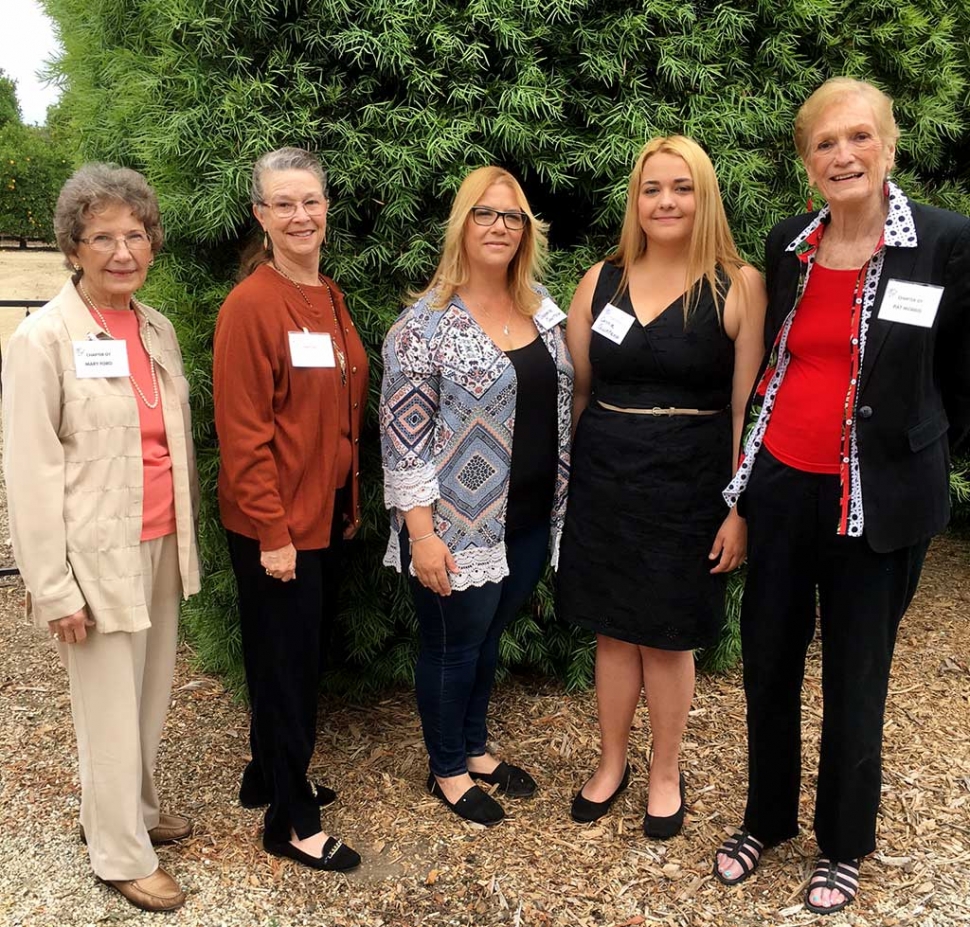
xmin=741 ymin=448 xmax=929 ymax=860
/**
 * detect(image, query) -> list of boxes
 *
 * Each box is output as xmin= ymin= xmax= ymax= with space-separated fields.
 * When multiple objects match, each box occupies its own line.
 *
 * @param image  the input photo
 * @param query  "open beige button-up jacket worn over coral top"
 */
xmin=3 ymin=281 xmax=199 ymax=633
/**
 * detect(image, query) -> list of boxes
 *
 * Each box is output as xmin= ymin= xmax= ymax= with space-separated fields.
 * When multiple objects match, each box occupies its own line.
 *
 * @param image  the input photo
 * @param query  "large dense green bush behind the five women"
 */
xmin=45 ymin=0 xmax=970 ymax=688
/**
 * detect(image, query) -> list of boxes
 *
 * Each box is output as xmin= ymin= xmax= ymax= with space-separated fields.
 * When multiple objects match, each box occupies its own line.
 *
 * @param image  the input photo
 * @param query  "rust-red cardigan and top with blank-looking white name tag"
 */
xmin=212 ymin=264 xmax=367 ymax=550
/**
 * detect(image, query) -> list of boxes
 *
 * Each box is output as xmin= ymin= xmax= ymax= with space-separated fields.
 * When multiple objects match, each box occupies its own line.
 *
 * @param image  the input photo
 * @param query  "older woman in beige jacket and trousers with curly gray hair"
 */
xmin=3 ymin=164 xmax=199 ymax=911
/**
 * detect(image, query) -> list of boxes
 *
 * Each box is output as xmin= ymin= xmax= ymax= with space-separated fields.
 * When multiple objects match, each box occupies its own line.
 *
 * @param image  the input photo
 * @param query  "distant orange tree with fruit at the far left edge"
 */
xmin=0 ymin=122 xmax=71 ymax=245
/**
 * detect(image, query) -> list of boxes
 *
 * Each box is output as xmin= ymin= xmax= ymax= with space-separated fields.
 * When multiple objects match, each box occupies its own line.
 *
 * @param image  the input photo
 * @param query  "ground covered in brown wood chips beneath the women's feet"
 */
xmin=0 ymin=255 xmax=970 ymax=927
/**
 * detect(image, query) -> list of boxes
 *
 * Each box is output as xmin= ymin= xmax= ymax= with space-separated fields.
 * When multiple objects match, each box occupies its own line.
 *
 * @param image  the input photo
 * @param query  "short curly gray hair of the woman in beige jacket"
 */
xmin=54 ymin=161 xmax=165 ymax=269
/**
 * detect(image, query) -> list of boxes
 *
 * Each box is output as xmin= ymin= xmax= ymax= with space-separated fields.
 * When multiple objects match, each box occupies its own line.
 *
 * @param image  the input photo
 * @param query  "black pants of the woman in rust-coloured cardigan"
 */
xmin=226 ymin=509 xmax=341 ymax=840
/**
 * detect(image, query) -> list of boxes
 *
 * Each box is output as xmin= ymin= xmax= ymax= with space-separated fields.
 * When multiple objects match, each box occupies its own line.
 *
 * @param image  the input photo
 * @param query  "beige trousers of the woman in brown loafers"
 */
xmin=57 ymin=534 xmax=182 ymax=879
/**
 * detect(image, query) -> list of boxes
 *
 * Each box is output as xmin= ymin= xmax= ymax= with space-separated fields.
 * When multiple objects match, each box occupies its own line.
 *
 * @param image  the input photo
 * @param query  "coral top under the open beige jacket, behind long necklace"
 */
xmin=89 ymin=309 xmax=175 ymax=541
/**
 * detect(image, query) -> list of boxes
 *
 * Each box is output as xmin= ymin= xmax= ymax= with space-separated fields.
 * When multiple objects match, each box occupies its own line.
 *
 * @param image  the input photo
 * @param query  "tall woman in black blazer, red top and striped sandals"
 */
xmin=714 ymin=78 xmax=970 ymax=914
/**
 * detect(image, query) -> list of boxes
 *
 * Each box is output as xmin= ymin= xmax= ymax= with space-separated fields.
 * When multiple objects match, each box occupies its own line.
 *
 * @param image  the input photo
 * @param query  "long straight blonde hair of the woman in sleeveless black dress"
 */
xmin=607 ymin=135 xmax=746 ymax=324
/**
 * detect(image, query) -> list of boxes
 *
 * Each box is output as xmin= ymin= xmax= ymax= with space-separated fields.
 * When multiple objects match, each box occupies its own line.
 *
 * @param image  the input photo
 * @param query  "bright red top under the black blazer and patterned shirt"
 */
xmin=764 ymin=262 xmax=859 ymax=473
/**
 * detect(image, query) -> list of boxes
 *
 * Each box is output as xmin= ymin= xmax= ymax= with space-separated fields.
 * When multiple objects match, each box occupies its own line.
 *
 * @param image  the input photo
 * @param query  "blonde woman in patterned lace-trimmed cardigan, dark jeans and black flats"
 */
xmin=381 ymin=167 xmax=573 ymax=825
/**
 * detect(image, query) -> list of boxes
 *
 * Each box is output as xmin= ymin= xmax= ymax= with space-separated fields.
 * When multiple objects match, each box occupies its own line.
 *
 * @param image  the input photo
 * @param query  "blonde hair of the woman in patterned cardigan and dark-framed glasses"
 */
xmin=410 ymin=167 xmax=549 ymax=316
